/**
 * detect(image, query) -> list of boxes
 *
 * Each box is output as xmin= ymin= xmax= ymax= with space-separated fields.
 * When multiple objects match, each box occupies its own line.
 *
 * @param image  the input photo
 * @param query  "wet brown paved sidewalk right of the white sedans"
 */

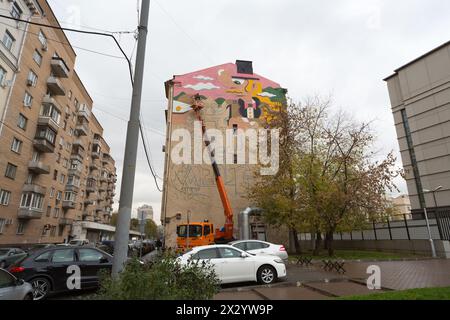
xmin=215 ymin=259 xmax=450 ymax=300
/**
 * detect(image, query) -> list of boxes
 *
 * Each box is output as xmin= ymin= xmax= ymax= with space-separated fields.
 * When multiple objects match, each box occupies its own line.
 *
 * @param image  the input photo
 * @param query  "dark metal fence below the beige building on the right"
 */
xmin=299 ymin=211 xmax=450 ymax=240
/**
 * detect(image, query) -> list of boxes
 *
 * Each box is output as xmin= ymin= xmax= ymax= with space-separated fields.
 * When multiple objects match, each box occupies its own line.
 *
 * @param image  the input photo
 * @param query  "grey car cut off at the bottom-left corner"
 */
xmin=0 ymin=269 xmax=33 ymax=300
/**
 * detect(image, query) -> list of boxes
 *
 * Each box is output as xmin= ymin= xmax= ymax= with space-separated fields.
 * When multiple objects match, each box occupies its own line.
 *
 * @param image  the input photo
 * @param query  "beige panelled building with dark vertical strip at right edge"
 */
xmin=385 ymin=42 xmax=450 ymax=219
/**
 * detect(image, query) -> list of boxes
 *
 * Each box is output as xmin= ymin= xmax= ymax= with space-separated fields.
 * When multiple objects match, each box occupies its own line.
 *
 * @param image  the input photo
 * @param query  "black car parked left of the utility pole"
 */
xmin=9 ymin=247 xmax=112 ymax=300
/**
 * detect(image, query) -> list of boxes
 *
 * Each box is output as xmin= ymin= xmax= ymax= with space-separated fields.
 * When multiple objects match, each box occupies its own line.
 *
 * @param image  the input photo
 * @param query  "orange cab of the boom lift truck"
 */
xmin=177 ymin=222 xmax=214 ymax=252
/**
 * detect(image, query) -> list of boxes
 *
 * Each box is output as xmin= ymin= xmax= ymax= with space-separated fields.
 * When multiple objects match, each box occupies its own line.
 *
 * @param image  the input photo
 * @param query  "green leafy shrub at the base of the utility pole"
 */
xmin=97 ymin=254 xmax=219 ymax=300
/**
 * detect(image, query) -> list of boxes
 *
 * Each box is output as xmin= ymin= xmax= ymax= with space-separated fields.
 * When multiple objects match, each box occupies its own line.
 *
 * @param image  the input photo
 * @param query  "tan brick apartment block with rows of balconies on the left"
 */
xmin=0 ymin=0 xmax=116 ymax=244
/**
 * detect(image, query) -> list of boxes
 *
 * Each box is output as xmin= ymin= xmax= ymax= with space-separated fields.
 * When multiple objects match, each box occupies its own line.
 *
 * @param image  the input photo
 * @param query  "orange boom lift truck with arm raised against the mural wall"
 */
xmin=177 ymin=94 xmax=234 ymax=251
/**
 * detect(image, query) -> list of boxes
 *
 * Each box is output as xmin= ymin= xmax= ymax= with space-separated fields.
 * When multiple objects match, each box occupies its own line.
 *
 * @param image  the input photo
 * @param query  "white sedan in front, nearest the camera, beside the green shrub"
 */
xmin=179 ymin=245 xmax=286 ymax=284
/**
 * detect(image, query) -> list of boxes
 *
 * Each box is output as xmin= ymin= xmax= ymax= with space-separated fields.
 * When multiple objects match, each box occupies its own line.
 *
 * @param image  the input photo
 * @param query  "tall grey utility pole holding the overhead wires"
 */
xmin=112 ymin=0 xmax=150 ymax=277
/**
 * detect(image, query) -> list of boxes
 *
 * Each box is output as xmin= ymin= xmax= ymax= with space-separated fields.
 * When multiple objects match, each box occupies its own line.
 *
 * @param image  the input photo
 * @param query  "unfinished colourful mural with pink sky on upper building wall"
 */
xmin=173 ymin=63 xmax=285 ymax=122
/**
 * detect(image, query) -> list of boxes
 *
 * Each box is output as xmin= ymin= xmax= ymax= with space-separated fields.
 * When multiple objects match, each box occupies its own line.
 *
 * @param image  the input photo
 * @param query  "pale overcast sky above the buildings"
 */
xmin=48 ymin=0 xmax=450 ymax=220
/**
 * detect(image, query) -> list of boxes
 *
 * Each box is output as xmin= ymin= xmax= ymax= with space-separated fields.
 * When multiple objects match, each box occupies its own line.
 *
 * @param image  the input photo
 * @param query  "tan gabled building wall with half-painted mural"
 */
xmin=161 ymin=60 xmax=287 ymax=247
